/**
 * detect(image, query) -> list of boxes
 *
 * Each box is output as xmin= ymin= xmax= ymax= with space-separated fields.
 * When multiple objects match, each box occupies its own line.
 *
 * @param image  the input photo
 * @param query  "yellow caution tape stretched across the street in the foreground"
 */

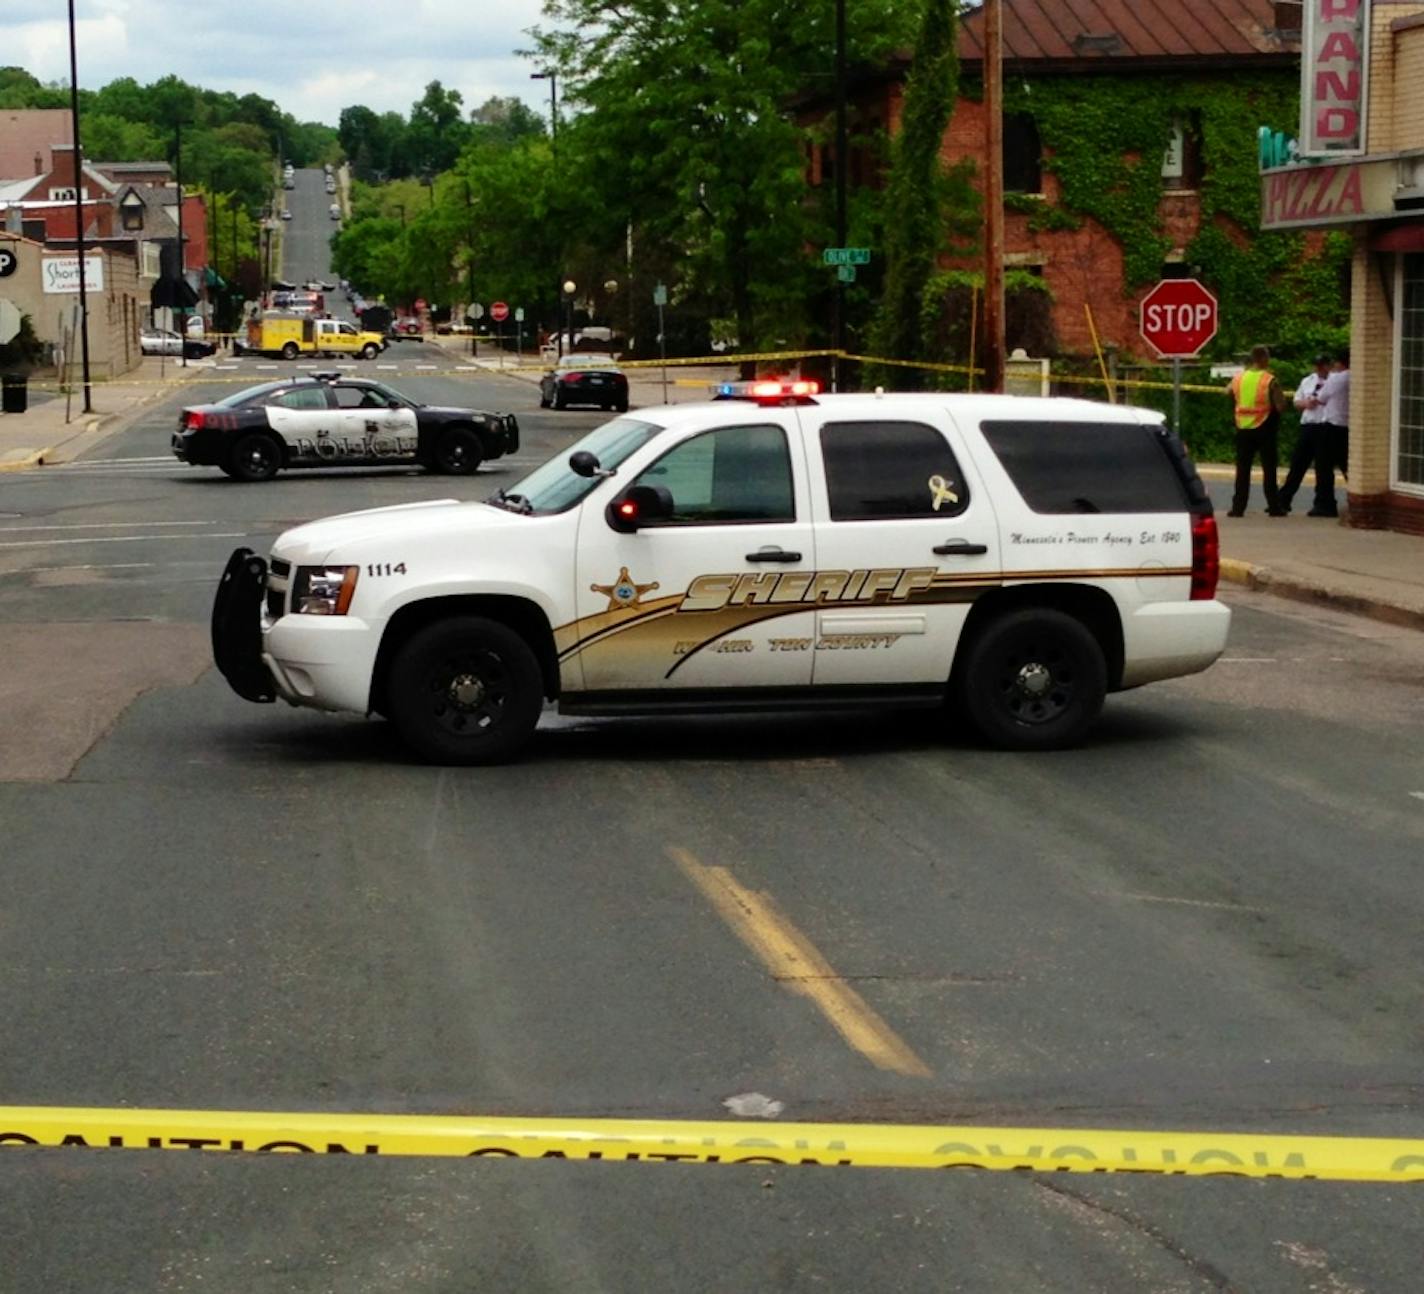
xmin=0 ymin=1106 xmax=1424 ymax=1182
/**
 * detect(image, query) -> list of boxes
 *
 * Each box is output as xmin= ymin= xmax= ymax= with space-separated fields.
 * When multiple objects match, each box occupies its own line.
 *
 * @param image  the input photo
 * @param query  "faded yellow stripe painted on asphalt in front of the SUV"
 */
xmin=668 ymin=846 xmax=930 ymax=1078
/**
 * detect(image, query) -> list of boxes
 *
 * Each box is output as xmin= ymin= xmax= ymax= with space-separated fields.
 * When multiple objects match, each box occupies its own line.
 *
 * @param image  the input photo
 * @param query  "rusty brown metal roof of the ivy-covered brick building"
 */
xmin=958 ymin=0 xmax=1300 ymax=71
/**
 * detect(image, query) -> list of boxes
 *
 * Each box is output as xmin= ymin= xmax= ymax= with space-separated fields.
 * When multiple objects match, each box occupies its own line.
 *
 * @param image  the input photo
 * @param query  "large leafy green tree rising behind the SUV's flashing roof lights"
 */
xmin=534 ymin=0 xmax=903 ymax=346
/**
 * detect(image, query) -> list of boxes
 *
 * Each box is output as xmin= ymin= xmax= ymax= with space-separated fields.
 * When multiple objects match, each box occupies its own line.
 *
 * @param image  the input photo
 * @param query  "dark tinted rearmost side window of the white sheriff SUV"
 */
xmin=980 ymin=421 xmax=1188 ymax=514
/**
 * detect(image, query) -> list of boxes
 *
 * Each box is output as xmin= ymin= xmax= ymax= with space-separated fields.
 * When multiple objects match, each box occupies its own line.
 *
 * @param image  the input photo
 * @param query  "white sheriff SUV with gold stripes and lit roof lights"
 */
xmin=212 ymin=382 xmax=1230 ymax=763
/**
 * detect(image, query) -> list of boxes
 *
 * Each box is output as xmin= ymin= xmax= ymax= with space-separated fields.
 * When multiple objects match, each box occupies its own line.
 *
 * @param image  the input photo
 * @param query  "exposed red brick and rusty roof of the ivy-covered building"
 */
xmin=805 ymin=0 xmax=1300 ymax=354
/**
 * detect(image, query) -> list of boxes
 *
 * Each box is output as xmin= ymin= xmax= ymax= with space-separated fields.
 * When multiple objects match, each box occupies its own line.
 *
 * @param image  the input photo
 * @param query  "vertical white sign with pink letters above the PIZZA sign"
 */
xmin=1300 ymin=0 xmax=1370 ymax=157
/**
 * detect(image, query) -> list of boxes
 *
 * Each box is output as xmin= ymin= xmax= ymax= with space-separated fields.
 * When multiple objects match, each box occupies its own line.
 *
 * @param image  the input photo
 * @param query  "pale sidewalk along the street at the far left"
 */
xmin=0 ymin=356 xmax=212 ymax=473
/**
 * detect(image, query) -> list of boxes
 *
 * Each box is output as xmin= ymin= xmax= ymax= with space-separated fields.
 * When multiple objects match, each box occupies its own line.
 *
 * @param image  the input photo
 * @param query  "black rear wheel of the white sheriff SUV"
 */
xmin=957 ymin=606 xmax=1108 ymax=750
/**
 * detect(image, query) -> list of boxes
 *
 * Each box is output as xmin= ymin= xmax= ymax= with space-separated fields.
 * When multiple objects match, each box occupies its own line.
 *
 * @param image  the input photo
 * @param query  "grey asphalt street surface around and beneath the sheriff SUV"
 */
xmin=0 ymin=358 xmax=1424 ymax=1291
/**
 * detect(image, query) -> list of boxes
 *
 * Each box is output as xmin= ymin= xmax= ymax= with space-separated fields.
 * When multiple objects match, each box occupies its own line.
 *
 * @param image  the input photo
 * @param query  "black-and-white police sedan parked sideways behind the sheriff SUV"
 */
xmin=172 ymin=373 xmax=520 ymax=481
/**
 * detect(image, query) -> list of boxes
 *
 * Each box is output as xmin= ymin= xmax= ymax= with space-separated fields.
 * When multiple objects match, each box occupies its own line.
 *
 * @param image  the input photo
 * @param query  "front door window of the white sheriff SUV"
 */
xmin=635 ymin=427 xmax=796 ymax=525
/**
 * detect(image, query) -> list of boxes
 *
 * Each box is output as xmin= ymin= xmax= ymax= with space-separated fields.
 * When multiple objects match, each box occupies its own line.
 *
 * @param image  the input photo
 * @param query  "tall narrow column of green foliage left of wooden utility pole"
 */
xmin=870 ymin=0 xmax=964 ymax=386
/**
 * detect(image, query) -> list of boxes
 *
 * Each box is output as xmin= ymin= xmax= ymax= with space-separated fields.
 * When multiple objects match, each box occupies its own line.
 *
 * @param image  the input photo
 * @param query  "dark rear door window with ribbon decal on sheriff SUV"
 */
xmin=820 ymin=423 xmax=970 ymax=521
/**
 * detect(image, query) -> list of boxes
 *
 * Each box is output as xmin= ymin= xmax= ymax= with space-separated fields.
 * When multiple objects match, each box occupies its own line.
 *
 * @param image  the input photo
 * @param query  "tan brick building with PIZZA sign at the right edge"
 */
xmin=1262 ymin=0 xmax=1424 ymax=534
